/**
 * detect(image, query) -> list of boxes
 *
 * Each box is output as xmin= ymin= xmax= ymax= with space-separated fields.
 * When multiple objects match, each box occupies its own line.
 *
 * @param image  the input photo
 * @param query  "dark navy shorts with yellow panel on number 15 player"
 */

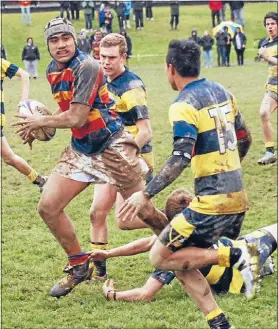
xmin=159 ymin=208 xmax=245 ymax=251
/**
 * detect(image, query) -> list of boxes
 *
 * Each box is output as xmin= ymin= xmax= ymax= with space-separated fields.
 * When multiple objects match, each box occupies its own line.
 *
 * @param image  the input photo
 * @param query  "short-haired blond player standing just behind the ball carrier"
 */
xmin=90 ymin=33 xmax=153 ymax=279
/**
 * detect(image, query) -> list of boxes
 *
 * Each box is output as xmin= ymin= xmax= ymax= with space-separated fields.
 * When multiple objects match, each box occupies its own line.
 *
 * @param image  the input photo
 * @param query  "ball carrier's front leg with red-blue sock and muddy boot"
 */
xmin=38 ymin=174 xmax=91 ymax=297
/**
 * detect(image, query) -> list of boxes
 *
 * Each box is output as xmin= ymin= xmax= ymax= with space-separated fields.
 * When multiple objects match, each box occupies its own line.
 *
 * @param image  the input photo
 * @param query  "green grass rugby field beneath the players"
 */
xmin=1 ymin=3 xmax=277 ymax=329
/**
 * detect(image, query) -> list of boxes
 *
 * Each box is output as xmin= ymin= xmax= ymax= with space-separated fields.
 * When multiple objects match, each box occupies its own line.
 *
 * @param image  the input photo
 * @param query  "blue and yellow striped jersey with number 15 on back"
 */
xmin=169 ymin=79 xmax=247 ymax=215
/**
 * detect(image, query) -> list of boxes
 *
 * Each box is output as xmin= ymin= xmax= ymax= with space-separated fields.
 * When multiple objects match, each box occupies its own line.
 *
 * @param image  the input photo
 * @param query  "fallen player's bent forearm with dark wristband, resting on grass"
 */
xmin=103 ymin=277 xmax=164 ymax=302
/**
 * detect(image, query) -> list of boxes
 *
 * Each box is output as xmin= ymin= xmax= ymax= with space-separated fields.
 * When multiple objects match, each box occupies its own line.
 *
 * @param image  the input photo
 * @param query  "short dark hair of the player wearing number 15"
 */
xmin=166 ymin=39 xmax=201 ymax=78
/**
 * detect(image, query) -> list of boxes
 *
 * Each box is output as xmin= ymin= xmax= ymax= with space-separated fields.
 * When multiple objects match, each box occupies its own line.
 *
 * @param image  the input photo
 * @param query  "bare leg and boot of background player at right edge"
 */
xmin=258 ymin=90 xmax=278 ymax=164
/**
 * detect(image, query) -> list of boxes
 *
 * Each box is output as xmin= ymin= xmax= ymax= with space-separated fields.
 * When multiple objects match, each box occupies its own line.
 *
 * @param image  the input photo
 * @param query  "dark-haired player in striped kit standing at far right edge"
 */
xmin=258 ymin=12 xmax=278 ymax=165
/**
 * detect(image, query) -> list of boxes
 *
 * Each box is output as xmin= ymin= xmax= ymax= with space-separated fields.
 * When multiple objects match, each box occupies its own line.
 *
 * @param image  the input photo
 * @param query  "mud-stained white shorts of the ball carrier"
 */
xmin=52 ymin=132 xmax=148 ymax=191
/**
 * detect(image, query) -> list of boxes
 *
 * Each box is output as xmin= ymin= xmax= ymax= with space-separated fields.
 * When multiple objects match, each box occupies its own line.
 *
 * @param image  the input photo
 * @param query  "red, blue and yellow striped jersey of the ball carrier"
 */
xmin=46 ymin=49 xmax=123 ymax=155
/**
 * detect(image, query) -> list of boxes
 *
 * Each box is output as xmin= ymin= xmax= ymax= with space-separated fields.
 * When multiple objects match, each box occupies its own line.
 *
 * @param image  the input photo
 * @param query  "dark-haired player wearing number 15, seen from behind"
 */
xmin=118 ymin=39 xmax=258 ymax=329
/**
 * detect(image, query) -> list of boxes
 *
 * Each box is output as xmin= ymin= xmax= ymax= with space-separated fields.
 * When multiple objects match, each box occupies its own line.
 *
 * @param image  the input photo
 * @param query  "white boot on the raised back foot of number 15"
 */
xmin=233 ymin=242 xmax=260 ymax=299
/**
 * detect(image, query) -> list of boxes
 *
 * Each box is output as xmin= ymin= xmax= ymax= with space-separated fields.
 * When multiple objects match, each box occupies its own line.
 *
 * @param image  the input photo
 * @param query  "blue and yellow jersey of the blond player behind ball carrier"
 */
xmin=108 ymin=68 xmax=152 ymax=153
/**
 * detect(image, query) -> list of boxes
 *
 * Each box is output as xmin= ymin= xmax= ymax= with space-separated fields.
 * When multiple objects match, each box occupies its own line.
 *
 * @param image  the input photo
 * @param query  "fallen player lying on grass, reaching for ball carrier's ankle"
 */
xmin=91 ymin=189 xmax=277 ymax=302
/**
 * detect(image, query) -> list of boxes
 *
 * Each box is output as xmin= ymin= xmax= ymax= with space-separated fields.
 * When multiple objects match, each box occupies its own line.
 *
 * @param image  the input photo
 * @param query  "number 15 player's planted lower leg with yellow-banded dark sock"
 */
xmin=175 ymin=270 xmax=232 ymax=329
